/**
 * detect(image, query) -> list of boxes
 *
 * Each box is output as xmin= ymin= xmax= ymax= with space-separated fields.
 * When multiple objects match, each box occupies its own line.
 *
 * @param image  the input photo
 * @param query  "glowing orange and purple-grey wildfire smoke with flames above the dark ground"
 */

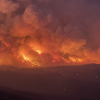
xmin=0 ymin=0 xmax=100 ymax=67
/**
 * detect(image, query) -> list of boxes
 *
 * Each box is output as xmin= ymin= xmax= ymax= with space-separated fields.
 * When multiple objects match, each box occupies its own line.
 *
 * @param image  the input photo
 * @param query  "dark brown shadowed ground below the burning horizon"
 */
xmin=0 ymin=64 xmax=100 ymax=100
